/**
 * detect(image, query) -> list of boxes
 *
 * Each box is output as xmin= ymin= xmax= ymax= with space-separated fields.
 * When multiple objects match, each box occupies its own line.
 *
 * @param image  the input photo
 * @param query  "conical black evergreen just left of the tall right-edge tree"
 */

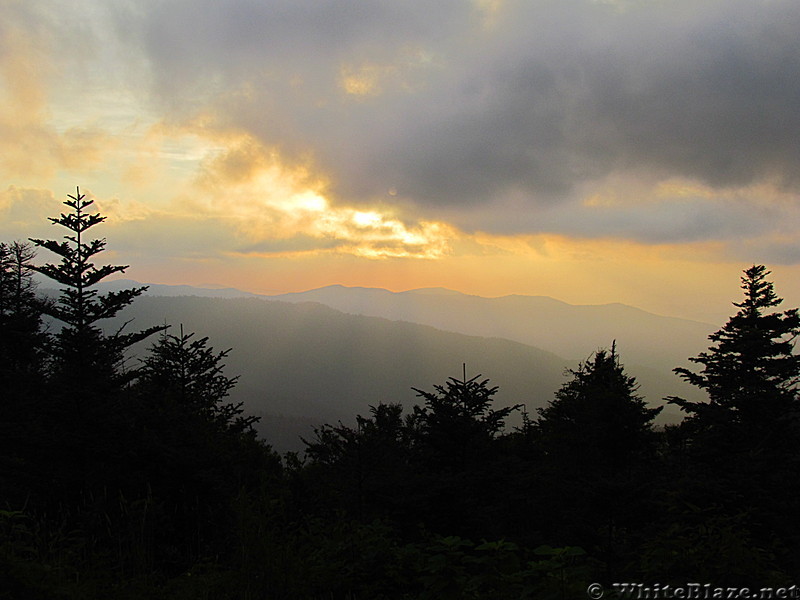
xmin=535 ymin=345 xmax=661 ymax=575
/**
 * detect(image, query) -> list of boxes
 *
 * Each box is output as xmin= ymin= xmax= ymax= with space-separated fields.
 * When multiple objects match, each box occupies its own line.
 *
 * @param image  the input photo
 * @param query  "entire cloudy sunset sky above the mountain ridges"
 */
xmin=0 ymin=0 xmax=800 ymax=324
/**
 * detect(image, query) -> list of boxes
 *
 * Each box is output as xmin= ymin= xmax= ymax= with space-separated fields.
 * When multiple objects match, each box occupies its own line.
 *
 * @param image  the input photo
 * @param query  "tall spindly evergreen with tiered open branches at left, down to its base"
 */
xmin=22 ymin=189 xmax=162 ymax=518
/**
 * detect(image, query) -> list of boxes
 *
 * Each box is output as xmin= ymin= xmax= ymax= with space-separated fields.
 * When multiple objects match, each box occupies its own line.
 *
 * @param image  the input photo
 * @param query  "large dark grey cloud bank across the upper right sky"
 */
xmin=115 ymin=0 xmax=800 ymax=226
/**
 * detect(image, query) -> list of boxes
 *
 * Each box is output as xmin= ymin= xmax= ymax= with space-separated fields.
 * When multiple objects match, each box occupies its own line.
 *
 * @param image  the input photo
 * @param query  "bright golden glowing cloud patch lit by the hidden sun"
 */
xmin=177 ymin=135 xmax=457 ymax=258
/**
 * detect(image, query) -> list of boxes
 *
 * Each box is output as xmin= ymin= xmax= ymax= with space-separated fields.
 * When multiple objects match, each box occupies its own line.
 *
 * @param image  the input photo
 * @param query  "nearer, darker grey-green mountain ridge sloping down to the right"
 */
xmin=100 ymin=295 xmax=566 ymax=450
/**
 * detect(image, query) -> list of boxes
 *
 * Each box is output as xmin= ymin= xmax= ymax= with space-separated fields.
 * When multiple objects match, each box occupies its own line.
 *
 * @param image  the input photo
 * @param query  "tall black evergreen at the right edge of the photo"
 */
xmin=667 ymin=265 xmax=800 ymax=581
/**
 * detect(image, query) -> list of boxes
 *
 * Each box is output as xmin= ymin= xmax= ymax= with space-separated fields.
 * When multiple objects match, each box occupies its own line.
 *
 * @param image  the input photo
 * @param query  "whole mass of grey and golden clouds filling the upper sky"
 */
xmin=6 ymin=0 xmax=800 ymax=257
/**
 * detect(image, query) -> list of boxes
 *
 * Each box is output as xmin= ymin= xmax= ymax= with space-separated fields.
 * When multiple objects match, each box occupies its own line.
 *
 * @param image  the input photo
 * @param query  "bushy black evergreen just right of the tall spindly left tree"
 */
xmin=132 ymin=328 xmax=272 ymax=572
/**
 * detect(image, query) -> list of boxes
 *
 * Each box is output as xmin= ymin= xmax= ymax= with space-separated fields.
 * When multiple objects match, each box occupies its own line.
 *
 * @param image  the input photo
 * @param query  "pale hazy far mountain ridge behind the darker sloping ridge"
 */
xmin=271 ymin=285 xmax=716 ymax=370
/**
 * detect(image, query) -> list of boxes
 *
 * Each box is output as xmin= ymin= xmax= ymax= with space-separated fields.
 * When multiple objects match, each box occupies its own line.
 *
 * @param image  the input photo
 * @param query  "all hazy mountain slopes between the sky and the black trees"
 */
xmin=94 ymin=280 xmax=715 ymax=450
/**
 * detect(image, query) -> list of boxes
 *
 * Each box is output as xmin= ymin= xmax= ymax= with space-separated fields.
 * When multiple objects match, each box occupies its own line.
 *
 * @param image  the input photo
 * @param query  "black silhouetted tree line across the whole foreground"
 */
xmin=0 ymin=190 xmax=800 ymax=600
